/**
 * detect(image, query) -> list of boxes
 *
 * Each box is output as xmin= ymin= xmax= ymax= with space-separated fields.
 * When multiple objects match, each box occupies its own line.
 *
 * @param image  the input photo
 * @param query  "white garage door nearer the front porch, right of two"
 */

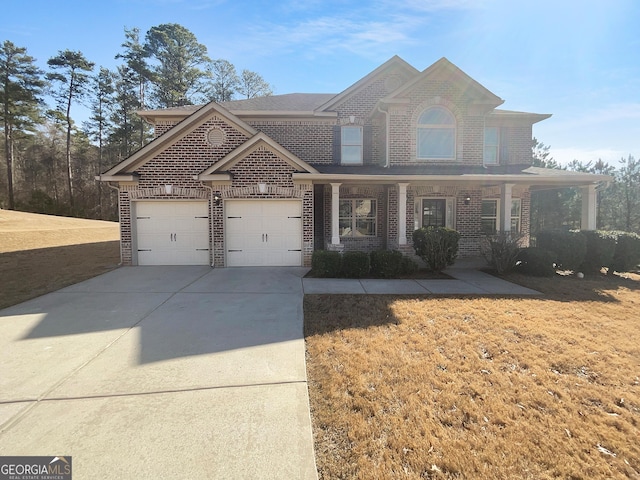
xmin=224 ymin=200 xmax=302 ymax=267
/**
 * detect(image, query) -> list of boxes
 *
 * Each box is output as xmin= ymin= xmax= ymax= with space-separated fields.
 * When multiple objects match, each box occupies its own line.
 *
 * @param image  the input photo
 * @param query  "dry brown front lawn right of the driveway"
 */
xmin=305 ymin=275 xmax=640 ymax=479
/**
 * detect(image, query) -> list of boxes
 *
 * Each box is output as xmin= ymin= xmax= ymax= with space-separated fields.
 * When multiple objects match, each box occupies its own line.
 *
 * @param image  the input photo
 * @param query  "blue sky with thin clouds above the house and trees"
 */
xmin=0 ymin=0 xmax=640 ymax=166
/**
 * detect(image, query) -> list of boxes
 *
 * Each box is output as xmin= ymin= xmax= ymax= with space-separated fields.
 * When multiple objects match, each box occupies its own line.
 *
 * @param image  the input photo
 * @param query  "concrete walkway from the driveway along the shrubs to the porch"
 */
xmin=302 ymin=268 xmax=540 ymax=295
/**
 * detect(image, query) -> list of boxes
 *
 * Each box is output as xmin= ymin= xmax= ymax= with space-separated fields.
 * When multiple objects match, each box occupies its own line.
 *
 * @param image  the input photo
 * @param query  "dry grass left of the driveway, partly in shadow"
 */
xmin=0 ymin=210 xmax=120 ymax=308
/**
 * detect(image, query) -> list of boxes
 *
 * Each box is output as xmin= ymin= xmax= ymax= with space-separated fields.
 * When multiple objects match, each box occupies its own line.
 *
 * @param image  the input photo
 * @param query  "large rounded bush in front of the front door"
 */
xmin=413 ymin=227 xmax=460 ymax=272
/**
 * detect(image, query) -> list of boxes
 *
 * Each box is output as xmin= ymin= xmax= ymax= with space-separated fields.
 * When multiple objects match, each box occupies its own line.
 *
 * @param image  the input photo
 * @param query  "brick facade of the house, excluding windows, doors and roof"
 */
xmin=109 ymin=57 xmax=544 ymax=267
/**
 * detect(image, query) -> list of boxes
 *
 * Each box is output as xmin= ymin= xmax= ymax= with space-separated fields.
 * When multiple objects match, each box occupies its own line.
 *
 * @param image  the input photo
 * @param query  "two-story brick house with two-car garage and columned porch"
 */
xmin=99 ymin=56 xmax=608 ymax=267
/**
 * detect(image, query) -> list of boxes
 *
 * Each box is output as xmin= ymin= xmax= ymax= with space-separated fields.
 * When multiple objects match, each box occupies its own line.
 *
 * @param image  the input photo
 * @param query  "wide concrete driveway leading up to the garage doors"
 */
xmin=0 ymin=267 xmax=317 ymax=479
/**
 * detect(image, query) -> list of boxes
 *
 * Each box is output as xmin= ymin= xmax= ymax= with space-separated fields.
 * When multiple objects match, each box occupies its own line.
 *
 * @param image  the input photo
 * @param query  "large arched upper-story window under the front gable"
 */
xmin=417 ymin=107 xmax=456 ymax=160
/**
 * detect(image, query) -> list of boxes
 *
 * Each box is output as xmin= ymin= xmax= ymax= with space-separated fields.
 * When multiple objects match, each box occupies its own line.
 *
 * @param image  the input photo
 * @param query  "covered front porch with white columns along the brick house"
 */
xmin=314 ymin=179 xmax=597 ymax=258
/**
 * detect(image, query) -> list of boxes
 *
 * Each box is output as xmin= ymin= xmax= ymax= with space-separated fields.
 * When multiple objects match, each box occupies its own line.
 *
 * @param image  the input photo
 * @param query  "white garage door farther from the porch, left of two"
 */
xmin=134 ymin=201 xmax=209 ymax=265
